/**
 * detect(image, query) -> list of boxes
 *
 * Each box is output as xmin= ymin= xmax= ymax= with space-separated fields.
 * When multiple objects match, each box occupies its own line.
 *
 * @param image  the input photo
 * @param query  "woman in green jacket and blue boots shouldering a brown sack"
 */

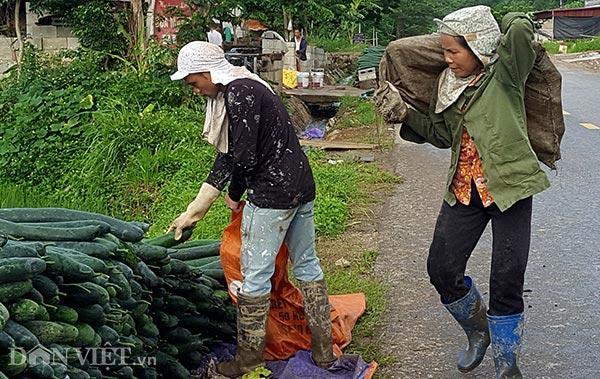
xmin=374 ymin=6 xmax=550 ymax=379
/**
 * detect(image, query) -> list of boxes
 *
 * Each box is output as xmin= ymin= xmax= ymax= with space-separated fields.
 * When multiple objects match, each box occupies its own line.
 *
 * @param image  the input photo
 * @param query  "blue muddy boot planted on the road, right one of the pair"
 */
xmin=488 ymin=313 xmax=525 ymax=379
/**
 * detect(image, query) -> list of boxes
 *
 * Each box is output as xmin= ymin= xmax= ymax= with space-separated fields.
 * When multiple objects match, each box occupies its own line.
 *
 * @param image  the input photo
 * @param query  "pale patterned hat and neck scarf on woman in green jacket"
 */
xmin=434 ymin=5 xmax=501 ymax=113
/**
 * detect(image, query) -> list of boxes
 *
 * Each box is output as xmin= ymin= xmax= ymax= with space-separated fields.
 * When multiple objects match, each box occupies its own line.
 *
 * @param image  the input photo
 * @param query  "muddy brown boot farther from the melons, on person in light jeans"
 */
xmin=299 ymin=280 xmax=337 ymax=369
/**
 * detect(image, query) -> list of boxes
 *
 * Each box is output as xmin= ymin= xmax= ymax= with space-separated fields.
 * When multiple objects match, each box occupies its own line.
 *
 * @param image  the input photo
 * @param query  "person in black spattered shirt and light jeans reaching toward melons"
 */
xmin=169 ymin=41 xmax=337 ymax=378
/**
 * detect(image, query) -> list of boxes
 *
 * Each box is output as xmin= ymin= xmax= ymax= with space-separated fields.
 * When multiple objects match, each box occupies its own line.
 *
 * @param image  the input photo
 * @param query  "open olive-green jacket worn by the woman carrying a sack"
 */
xmin=400 ymin=13 xmax=550 ymax=211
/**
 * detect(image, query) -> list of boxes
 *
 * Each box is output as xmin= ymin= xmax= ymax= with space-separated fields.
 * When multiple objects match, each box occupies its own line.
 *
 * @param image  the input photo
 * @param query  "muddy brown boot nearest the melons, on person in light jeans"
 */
xmin=217 ymin=292 xmax=271 ymax=378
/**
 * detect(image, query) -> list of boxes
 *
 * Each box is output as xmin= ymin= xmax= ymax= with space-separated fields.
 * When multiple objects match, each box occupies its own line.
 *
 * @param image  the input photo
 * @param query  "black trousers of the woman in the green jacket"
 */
xmin=427 ymin=183 xmax=532 ymax=316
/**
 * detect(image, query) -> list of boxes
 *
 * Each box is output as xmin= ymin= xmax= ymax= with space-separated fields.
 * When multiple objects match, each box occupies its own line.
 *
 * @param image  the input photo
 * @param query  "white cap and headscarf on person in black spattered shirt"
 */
xmin=171 ymin=41 xmax=275 ymax=153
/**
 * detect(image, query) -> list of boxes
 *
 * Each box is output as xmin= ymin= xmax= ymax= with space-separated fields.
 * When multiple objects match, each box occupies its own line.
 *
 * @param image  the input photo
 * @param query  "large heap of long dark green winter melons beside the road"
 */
xmin=0 ymin=208 xmax=235 ymax=379
